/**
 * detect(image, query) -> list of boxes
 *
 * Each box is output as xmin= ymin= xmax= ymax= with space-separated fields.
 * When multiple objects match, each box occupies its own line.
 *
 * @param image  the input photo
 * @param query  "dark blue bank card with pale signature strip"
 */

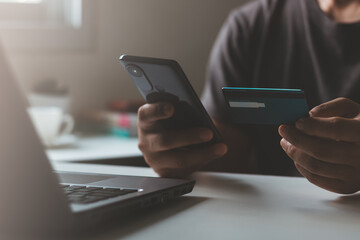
xmin=222 ymin=87 xmax=309 ymax=125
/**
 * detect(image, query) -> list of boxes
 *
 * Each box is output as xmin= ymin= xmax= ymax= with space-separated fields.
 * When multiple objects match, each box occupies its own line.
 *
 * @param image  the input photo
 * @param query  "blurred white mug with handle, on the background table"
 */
xmin=28 ymin=107 xmax=74 ymax=147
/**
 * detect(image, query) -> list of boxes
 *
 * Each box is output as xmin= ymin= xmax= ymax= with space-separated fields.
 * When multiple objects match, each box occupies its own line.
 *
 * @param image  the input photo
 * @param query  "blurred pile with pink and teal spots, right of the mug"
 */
xmin=81 ymin=100 xmax=144 ymax=138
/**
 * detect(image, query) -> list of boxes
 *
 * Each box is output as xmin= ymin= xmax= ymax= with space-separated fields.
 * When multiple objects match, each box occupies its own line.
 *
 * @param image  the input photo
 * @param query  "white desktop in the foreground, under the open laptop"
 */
xmin=53 ymin=163 xmax=360 ymax=240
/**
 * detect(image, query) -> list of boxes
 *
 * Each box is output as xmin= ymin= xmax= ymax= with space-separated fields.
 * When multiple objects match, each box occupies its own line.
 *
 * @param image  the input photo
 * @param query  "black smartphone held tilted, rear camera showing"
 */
xmin=120 ymin=55 xmax=222 ymax=143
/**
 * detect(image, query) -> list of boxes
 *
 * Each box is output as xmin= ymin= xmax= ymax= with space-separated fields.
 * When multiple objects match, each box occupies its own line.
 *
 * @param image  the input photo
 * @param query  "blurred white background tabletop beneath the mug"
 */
xmin=46 ymin=136 xmax=141 ymax=161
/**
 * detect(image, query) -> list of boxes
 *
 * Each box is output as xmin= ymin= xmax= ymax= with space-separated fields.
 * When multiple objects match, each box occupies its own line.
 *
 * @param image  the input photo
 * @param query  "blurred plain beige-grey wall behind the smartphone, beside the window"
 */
xmin=5 ymin=0 xmax=249 ymax=112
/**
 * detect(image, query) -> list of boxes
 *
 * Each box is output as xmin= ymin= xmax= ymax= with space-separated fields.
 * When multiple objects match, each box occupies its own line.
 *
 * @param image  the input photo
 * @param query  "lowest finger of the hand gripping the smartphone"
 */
xmin=148 ymin=143 xmax=227 ymax=171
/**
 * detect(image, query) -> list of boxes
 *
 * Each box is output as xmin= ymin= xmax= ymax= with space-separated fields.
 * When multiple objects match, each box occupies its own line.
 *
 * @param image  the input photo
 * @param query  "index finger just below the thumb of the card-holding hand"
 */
xmin=296 ymin=117 xmax=360 ymax=142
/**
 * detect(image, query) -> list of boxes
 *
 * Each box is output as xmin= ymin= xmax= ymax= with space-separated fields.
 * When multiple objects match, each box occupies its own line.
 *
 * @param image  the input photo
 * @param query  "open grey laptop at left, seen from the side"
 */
xmin=0 ymin=42 xmax=195 ymax=236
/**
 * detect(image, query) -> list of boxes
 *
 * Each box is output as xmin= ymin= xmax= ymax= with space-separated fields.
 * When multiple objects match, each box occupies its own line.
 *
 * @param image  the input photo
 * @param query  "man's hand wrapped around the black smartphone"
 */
xmin=138 ymin=102 xmax=227 ymax=177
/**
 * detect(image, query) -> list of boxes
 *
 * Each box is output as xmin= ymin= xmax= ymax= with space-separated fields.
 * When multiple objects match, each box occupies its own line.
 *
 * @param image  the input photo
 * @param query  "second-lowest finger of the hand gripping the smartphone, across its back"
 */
xmin=144 ymin=128 xmax=213 ymax=152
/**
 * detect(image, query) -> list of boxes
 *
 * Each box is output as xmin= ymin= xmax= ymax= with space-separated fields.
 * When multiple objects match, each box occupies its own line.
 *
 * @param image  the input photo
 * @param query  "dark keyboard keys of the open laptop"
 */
xmin=60 ymin=184 xmax=138 ymax=204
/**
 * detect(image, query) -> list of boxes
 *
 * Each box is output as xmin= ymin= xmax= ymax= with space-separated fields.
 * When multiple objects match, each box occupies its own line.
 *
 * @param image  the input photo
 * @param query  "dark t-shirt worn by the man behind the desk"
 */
xmin=203 ymin=0 xmax=360 ymax=175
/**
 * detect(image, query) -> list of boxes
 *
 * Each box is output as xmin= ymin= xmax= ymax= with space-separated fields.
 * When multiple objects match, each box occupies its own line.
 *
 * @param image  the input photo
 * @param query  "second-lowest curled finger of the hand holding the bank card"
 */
xmin=280 ymin=139 xmax=352 ymax=180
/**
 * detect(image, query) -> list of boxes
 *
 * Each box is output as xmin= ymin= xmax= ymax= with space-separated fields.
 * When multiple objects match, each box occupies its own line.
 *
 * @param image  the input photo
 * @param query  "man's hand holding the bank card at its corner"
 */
xmin=279 ymin=98 xmax=360 ymax=194
